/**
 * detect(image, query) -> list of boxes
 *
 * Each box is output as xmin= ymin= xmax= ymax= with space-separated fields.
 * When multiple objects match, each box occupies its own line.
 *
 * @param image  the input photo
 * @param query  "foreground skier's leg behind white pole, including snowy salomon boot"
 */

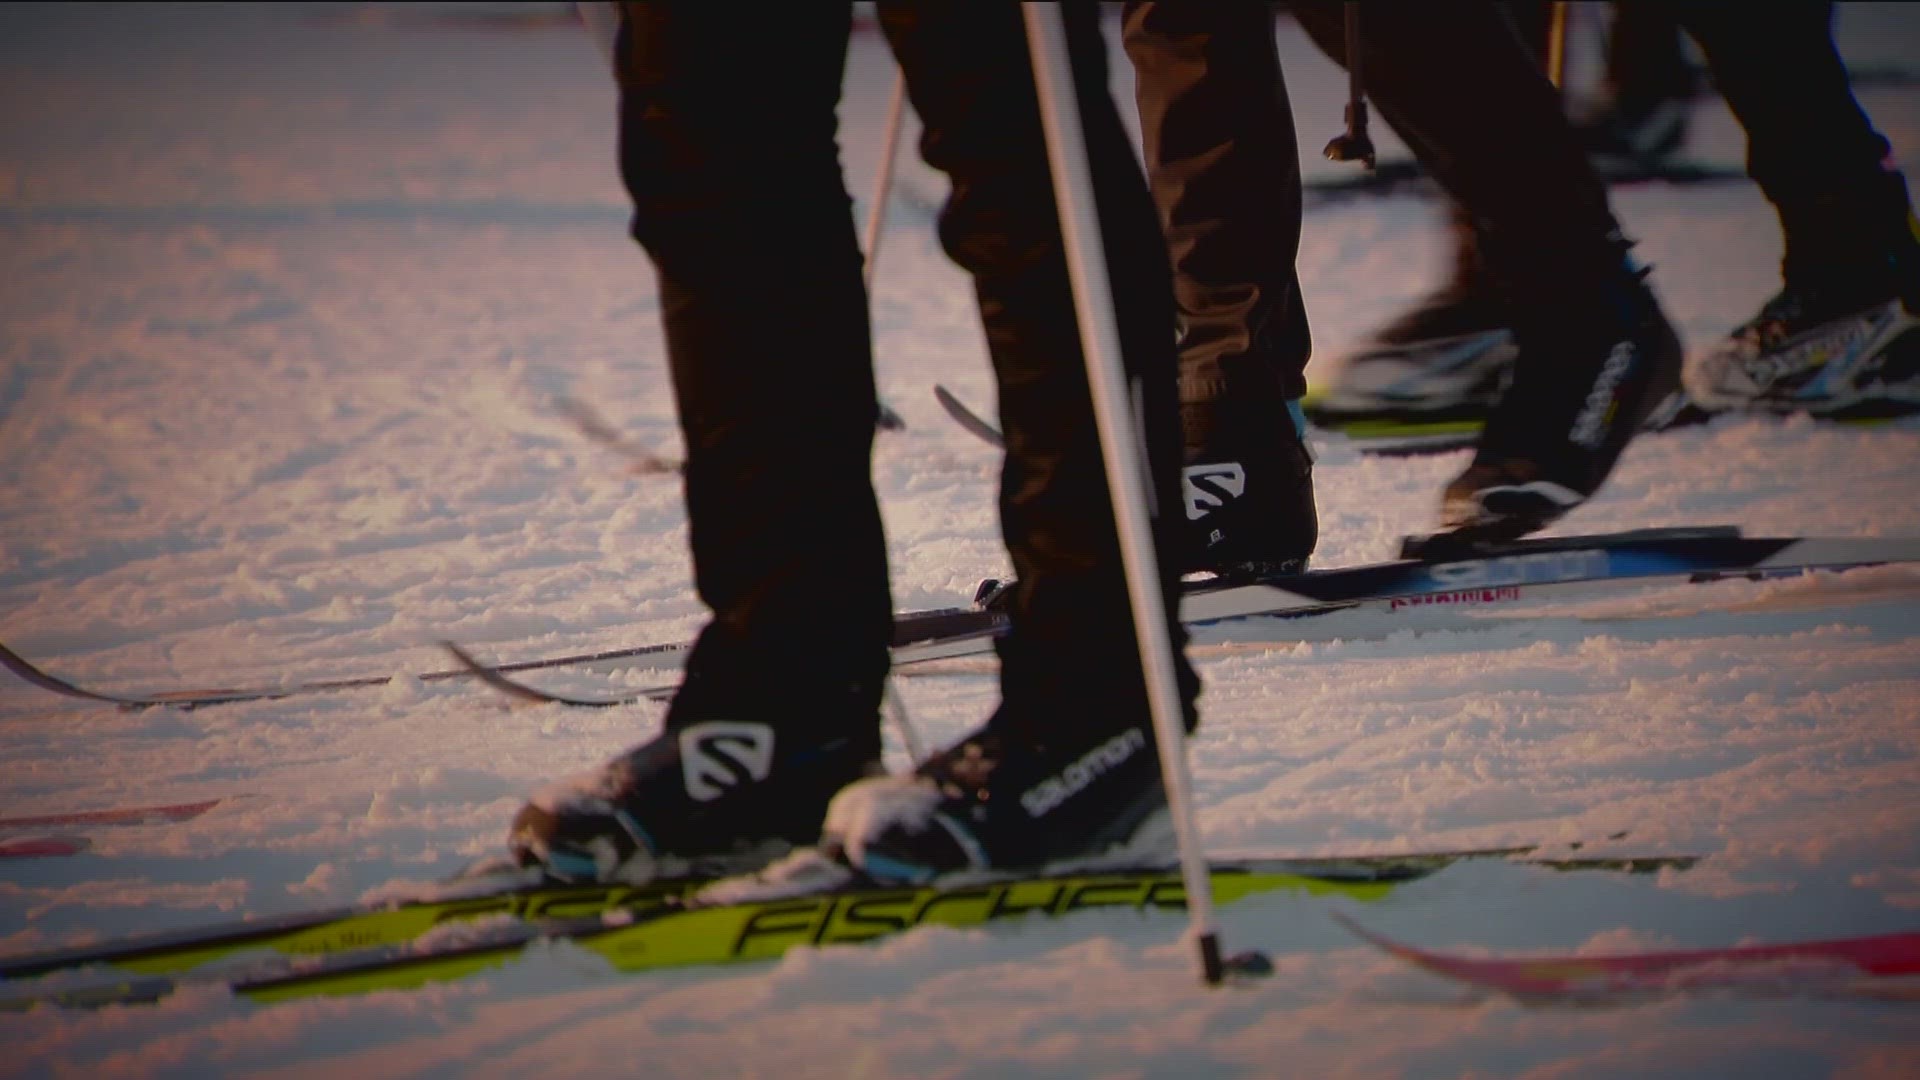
xmin=828 ymin=0 xmax=1196 ymax=878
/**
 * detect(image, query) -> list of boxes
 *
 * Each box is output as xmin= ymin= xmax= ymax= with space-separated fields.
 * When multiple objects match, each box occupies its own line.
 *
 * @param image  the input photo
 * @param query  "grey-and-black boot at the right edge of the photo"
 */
xmin=1686 ymin=269 xmax=1920 ymax=419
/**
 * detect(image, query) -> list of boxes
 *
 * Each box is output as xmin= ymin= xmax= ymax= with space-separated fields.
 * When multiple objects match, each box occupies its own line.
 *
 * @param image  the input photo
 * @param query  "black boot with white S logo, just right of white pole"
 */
xmin=1181 ymin=402 xmax=1319 ymax=575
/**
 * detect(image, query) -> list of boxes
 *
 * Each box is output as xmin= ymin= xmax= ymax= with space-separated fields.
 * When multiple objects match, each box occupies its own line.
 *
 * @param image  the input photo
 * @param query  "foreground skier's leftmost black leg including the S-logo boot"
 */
xmin=511 ymin=0 xmax=891 ymax=880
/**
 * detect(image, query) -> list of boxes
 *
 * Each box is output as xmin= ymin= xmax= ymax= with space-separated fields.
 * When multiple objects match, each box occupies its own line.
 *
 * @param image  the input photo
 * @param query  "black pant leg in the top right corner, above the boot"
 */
xmin=1676 ymin=0 xmax=1910 ymax=284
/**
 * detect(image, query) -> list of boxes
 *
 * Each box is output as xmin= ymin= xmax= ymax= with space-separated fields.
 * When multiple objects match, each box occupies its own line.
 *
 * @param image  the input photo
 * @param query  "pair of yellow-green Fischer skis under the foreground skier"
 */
xmin=0 ymin=847 xmax=1693 ymax=1009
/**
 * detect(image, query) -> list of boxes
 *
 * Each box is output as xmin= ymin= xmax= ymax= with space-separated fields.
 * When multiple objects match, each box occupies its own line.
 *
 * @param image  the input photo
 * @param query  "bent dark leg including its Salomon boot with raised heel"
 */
xmin=1294 ymin=0 xmax=1680 ymax=536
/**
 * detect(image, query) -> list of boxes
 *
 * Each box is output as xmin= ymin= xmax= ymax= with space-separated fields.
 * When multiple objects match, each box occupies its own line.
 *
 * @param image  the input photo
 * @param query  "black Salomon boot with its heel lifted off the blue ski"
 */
xmin=1440 ymin=269 xmax=1684 ymax=540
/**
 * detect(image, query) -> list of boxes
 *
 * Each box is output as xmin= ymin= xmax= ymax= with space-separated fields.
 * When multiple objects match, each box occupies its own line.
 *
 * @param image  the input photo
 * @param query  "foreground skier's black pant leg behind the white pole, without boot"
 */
xmin=879 ymin=0 xmax=1198 ymax=740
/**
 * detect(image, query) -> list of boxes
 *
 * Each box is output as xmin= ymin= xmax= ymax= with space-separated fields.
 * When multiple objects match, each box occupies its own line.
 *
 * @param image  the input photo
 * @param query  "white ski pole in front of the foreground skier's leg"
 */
xmin=1021 ymin=4 xmax=1225 ymax=984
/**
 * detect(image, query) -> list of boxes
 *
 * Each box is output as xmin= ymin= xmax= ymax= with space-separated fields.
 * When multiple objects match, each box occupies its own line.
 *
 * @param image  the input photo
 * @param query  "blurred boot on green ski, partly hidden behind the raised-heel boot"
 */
xmin=1306 ymin=279 xmax=1515 ymax=429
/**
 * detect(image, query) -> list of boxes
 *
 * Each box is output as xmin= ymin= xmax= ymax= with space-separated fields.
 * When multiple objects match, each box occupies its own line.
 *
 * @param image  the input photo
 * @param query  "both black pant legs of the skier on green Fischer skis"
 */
xmin=620 ymin=0 xmax=1198 ymax=738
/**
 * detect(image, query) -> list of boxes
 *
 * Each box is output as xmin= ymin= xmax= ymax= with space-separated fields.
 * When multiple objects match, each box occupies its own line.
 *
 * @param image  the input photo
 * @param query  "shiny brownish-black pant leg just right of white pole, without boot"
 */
xmin=1123 ymin=0 xmax=1311 ymax=441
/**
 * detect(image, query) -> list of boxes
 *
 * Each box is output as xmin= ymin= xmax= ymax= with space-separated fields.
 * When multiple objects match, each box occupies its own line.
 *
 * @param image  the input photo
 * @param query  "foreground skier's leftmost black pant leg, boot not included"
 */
xmin=620 ymin=0 xmax=893 ymax=734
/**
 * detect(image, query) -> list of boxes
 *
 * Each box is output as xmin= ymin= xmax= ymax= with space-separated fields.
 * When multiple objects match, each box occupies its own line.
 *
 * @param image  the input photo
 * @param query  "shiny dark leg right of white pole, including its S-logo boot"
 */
xmin=1125 ymin=0 xmax=1319 ymax=569
